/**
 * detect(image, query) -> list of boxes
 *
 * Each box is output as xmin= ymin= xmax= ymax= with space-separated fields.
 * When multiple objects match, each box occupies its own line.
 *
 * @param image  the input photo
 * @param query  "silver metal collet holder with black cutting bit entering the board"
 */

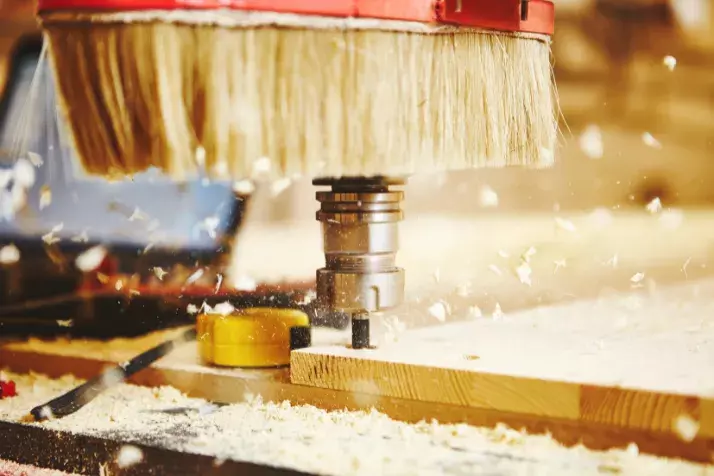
xmin=312 ymin=177 xmax=405 ymax=349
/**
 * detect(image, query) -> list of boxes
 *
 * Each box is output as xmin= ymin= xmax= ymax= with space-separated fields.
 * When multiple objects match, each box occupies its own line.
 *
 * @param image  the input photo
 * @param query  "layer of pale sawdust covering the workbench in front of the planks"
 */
xmin=0 ymin=373 xmax=714 ymax=476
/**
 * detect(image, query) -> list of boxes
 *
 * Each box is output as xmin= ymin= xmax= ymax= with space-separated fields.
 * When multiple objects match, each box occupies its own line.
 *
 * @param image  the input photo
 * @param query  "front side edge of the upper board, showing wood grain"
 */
xmin=290 ymin=349 xmax=714 ymax=444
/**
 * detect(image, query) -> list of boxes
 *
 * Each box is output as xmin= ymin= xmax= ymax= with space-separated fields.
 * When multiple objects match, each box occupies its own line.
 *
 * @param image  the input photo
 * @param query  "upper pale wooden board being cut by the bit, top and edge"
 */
xmin=291 ymin=281 xmax=714 ymax=444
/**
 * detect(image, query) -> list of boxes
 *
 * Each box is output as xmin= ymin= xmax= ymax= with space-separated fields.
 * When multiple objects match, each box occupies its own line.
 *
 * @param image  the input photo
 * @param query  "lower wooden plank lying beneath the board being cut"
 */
xmin=0 ymin=326 xmax=714 ymax=462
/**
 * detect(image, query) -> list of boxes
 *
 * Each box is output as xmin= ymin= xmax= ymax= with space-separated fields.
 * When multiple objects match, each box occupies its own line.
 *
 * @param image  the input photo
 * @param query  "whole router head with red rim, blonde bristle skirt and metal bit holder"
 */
xmin=22 ymin=0 xmax=556 ymax=349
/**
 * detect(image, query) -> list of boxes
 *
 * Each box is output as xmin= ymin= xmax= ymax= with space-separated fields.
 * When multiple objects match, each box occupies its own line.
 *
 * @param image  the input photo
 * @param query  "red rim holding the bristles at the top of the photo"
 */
xmin=38 ymin=0 xmax=555 ymax=35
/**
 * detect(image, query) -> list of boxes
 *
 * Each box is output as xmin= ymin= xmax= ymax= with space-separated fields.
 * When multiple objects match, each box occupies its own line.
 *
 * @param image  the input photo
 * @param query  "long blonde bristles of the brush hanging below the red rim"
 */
xmin=37 ymin=13 xmax=557 ymax=180
